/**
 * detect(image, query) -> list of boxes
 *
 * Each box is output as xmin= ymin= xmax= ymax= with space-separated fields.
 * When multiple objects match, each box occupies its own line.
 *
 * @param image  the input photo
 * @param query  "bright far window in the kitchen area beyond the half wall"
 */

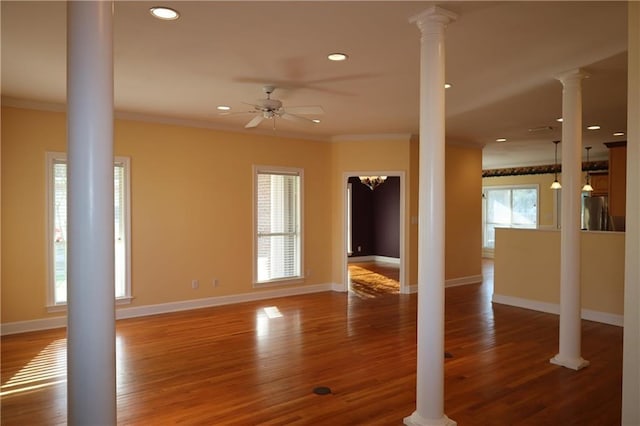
xmin=482 ymin=185 xmax=538 ymax=249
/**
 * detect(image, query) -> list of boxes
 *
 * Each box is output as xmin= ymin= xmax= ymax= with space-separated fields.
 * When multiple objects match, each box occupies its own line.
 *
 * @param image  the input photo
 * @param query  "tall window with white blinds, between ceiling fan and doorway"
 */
xmin=254 ymin=167 xmax=303 ymax=284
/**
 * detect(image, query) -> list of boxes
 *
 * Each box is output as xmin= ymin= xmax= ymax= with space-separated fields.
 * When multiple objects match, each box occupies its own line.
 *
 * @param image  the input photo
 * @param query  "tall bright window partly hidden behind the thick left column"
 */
xmin=47 ymin=153 xmax=131 ymax=306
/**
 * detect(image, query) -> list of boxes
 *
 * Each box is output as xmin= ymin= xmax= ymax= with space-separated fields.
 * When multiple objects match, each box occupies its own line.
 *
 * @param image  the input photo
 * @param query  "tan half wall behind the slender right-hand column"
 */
xmin=494 ymin=229 xmax=625 ymax=315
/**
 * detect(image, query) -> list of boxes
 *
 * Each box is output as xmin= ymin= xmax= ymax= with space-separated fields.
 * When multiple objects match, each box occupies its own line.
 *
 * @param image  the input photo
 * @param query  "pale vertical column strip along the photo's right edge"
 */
xmin=622 ymin=1 xmax=640 ymax=425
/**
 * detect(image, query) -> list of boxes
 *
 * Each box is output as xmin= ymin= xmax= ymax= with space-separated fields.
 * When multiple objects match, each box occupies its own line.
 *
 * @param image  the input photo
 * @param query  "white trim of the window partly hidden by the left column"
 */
xmin=45 ymin=151 xmax=133 ymax=312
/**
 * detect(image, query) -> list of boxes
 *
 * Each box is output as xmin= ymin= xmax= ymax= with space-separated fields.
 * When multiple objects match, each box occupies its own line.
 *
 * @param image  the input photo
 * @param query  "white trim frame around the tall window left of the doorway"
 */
xmin=251 ymin=164 xmax=305 ymax=288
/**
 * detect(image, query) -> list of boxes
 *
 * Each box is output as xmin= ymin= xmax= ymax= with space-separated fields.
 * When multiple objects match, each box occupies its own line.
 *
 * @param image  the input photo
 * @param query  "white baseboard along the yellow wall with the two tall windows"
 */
xmin=0 ymin=284 xmax=336 ymax=336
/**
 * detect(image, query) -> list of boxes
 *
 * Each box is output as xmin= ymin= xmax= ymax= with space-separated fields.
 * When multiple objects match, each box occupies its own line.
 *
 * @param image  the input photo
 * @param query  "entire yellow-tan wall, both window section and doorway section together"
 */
xmin=1 ymin=108 xmax=481 ymax=324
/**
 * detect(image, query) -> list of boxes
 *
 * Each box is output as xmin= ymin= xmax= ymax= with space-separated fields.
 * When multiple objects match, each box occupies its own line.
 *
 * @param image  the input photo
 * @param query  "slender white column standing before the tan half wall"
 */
xmin=551 ymin=70 xmax=589 ymax=370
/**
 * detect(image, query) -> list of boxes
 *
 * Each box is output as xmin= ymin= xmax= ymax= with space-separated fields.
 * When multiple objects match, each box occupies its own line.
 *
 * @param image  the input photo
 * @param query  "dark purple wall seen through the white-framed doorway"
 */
xmin=349 ymin=176 xmax=400 ymax=257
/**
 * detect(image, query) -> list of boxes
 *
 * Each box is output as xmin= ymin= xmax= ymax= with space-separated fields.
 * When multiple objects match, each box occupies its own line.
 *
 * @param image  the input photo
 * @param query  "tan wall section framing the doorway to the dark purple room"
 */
xmin=332 ymin=138 xmax=482 ymax=285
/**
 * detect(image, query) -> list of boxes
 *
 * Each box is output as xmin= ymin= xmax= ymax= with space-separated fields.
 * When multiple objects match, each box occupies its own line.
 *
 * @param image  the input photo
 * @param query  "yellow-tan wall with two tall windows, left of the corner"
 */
xmin=2 ymin=108 xmax=332 ymax=323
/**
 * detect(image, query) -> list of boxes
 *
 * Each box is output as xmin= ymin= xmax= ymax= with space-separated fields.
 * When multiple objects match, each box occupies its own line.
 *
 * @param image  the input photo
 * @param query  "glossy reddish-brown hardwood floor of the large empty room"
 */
xmin=1 ymin=262 xmax=622 ymax=426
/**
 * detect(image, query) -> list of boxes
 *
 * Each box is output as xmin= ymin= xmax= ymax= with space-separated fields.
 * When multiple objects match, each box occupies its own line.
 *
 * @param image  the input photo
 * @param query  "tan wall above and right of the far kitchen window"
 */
xmin=482 ymin=174 xmax=557 ymax=228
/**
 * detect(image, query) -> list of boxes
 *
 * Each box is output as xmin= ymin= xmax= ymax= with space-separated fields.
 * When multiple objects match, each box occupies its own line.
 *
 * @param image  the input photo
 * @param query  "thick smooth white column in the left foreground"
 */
xmin=67 ymin=1 xmax=116 ymax=425
